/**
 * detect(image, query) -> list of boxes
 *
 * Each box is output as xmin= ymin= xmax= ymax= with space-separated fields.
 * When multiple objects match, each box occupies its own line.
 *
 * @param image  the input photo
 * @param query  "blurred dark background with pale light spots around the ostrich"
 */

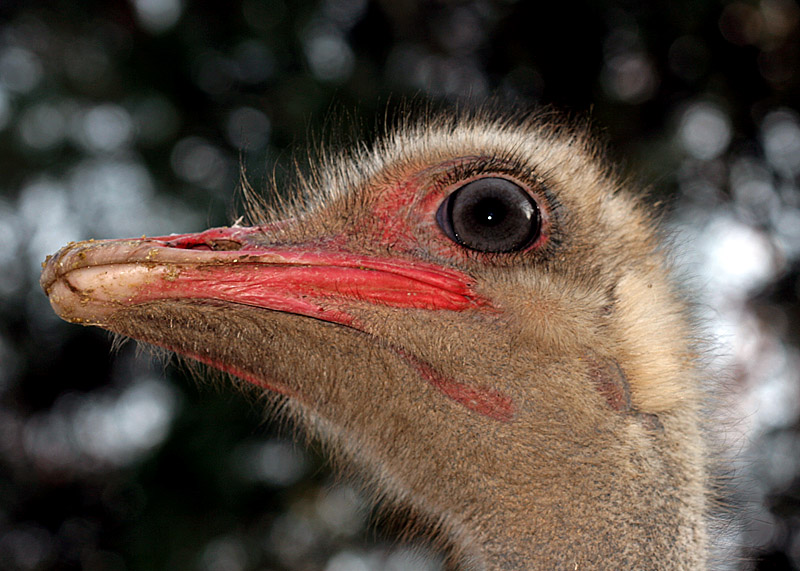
xmin=0 ymin=0 xmax=800 ymax=571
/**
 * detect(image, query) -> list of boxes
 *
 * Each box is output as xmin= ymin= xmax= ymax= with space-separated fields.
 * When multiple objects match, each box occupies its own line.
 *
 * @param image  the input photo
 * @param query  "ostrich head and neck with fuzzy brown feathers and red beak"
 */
xmin=41 ymin=112 xmax=708 ymax=570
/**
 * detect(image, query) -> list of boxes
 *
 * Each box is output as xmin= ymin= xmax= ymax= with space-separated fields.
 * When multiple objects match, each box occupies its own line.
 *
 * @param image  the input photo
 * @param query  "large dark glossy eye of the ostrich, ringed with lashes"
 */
xmin=436 ymin=177 xmax=541 ymax=252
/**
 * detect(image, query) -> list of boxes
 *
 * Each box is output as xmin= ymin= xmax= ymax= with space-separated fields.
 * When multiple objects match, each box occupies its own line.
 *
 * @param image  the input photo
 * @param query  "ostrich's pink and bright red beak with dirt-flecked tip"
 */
xmin=40 ymin=226 xmax=487 ymax=327
